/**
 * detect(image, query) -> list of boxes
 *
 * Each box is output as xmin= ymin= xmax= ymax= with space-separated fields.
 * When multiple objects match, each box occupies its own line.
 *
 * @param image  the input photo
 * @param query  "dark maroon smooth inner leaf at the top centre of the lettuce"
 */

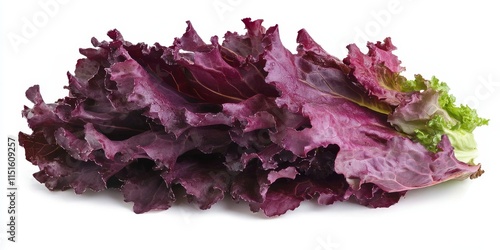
xmin=172 ymin=21 xmax=277 ymax=103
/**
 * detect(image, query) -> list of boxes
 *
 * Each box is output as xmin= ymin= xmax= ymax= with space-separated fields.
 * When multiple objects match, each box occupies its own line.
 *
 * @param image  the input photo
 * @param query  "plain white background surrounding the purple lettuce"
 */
xmin=0 ymin=0 xmax=500 ymax=250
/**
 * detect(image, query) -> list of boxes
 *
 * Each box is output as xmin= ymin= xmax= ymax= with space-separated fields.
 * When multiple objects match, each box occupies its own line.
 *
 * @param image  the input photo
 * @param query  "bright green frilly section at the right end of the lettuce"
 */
xmin=391 ymin=75 xmax=488 ymax=164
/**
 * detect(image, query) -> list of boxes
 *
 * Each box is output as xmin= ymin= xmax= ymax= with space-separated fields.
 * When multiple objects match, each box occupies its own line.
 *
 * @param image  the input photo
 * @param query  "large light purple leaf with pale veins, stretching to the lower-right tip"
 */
xmin=265 ymin=23 xmax=478 ymax=195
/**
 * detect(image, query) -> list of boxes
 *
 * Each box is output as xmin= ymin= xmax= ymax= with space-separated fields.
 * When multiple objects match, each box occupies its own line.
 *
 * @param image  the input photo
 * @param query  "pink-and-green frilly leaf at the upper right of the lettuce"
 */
xmin=345 ymin=39 xmax=488 ymax=164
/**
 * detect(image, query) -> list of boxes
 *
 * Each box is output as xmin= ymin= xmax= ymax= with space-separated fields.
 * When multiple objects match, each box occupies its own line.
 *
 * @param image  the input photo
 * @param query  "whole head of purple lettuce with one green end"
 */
xmin=19 ymin=18 xmax=487 ymax=216
